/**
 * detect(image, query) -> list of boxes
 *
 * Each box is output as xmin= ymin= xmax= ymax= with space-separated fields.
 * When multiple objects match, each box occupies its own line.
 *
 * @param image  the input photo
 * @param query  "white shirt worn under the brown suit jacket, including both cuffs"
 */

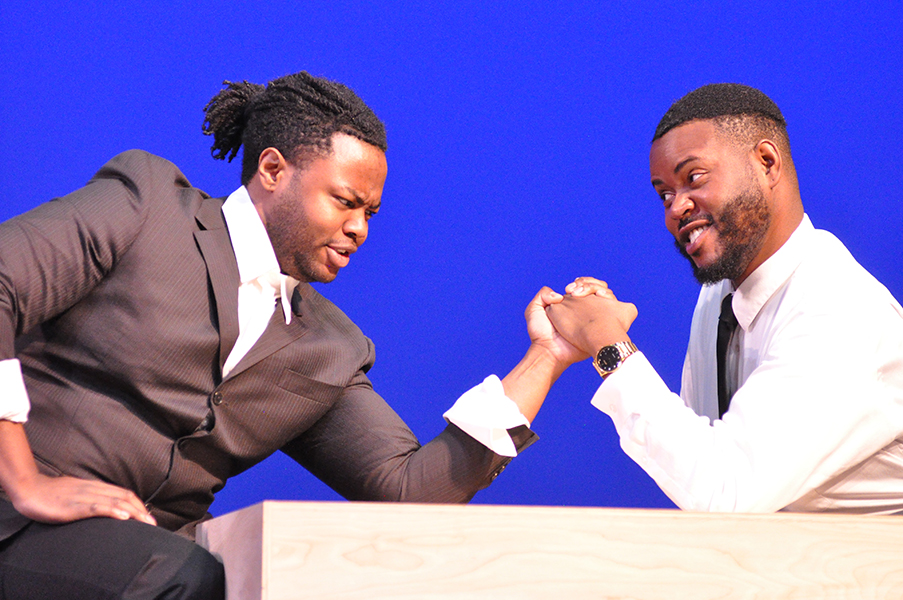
xmin=0 ymin=186 xmax=530 ymax=456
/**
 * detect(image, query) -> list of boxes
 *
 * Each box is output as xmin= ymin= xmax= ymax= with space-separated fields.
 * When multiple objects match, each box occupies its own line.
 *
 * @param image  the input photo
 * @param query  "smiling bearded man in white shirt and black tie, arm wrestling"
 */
xmin=547 ymin=84 xmax=903 ymax=514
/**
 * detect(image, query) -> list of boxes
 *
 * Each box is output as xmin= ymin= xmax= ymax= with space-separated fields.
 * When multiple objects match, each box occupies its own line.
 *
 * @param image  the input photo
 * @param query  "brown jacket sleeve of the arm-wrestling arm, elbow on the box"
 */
xmin=282 ymin=338 xmax=537 ymax=502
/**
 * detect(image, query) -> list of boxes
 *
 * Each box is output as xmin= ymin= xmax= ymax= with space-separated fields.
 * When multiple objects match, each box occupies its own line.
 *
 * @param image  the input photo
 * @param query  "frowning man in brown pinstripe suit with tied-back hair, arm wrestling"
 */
xmin=0 ymin=73 xmax=585 ymax=598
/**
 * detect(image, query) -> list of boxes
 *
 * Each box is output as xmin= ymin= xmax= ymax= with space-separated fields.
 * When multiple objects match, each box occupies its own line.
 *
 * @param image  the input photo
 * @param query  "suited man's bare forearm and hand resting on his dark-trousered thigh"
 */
xmin=0 ymin=420 xmax=157 ymax=525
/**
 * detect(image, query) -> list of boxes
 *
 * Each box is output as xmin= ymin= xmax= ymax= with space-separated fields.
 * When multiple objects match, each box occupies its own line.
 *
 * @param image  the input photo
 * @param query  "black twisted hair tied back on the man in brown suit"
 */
xmin=203 ymin=71 xmax=387 ymax=184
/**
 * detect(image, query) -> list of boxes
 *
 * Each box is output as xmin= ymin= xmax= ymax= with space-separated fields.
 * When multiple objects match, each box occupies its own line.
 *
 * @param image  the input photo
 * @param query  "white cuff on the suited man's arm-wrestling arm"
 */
xmin=442 ymin=375 xmax=530 ymax=456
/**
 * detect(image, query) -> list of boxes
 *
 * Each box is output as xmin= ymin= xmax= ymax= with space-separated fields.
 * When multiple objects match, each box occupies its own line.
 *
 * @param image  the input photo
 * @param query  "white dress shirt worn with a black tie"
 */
xmin=592 ymin=217 xmax=903 ymax=513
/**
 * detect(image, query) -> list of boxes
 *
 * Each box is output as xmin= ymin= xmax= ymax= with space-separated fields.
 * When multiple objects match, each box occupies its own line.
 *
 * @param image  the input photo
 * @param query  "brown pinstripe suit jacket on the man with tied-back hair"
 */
xmin=0 ymin=150 xmax=535 ymax=539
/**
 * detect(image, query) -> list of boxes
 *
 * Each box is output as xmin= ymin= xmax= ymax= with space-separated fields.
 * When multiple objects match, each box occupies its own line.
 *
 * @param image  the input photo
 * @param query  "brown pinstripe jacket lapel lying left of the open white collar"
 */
xmin=194 ymin=198 xmax=240 ymax=370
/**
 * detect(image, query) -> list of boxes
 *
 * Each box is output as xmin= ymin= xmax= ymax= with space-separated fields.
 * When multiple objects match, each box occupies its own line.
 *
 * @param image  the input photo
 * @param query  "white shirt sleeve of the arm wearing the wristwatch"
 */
xmin=592 ymin=298 xmax=903 ymax=512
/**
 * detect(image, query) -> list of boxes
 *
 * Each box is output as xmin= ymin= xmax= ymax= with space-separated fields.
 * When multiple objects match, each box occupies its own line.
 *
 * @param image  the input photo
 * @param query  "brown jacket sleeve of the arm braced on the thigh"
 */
xmin=0 ymin=151 xmax=187 ymax=420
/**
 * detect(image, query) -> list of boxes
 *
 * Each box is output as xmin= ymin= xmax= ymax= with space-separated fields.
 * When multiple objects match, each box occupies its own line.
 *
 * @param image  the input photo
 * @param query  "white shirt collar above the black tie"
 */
xmin=732 ymin=214 xmax=815 ymax=331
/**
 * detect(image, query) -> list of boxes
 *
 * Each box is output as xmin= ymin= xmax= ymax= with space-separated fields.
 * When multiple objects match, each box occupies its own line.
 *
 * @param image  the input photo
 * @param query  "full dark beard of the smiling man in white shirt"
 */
xmin=674 ymin=182 xmax=771 ymax=285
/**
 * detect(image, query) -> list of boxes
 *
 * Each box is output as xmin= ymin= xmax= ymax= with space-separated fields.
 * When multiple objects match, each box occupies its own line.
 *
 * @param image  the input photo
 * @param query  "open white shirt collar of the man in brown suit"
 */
xmin=223 ymin=186 xmax=298 ymax=324
